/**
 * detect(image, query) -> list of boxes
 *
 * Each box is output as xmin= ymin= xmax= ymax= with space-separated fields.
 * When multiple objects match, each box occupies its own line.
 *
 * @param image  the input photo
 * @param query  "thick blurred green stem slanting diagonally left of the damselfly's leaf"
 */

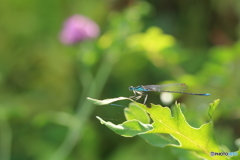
xmin=50 ymin=52 xmax=114 ymax=160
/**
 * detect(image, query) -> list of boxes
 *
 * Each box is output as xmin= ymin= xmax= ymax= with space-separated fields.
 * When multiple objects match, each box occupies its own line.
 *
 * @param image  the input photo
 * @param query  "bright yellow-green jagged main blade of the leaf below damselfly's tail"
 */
xmin=138 ymin=101 xmax=226 ymax=160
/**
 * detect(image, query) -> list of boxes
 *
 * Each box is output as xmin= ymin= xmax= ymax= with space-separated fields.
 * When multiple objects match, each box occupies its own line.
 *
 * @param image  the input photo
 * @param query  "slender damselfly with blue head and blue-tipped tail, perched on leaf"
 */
xmin=129 ymin=83 xmax=210 ymax=104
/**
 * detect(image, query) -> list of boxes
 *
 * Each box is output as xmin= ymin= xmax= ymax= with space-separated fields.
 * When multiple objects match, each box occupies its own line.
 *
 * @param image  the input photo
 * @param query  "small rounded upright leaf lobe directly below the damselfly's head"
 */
xmin=124 ymin=103 xmax=150 ymax=124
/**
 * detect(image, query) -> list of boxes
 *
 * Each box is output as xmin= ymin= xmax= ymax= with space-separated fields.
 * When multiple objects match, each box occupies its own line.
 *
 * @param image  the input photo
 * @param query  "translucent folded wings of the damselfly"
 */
xmin=143 ymin=83 xmax=188 ymax=92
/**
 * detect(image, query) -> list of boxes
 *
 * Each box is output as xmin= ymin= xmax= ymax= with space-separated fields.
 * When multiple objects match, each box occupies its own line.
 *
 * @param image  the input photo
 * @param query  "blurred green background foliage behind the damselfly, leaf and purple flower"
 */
xmin=0 ymin=0 xmax=240 ymax=160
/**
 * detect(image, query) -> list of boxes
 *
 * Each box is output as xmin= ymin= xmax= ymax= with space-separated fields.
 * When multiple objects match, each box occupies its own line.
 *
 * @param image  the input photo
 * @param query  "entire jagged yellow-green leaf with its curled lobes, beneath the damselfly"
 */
xmin=89 ymin=97 xmax=239 ymax=160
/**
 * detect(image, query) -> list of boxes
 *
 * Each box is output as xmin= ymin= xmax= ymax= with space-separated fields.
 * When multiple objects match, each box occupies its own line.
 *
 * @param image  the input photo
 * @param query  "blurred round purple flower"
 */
xmin=60 ymin=15 xmax=99 ymax=44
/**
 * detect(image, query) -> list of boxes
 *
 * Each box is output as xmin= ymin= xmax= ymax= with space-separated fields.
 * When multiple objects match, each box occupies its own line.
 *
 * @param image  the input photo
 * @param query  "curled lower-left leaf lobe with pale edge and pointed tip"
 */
xmin=97 ymin=117 xmax=153 ymax=137
